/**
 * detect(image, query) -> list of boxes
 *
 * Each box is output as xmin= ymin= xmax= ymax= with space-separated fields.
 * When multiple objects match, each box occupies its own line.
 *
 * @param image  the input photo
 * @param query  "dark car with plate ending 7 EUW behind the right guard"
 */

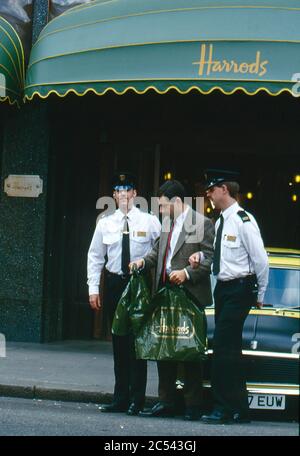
xmin=204 ymin=248 xmax=300 ymax=419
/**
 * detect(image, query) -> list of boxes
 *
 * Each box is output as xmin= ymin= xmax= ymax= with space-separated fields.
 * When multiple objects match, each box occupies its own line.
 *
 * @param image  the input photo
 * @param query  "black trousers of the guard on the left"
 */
xmin=104 ymin=271 xmax=147 ymax=408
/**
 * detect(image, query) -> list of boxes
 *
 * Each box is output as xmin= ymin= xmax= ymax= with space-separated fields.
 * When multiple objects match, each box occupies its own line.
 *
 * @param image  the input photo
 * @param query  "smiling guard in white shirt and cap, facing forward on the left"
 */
xmin=87 ymin=172 xmax=161 ymax=415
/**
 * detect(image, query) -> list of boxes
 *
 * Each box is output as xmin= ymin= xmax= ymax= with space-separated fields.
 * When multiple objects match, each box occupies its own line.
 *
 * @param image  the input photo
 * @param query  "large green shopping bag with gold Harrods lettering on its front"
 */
xmin=135 ymin=285 xmax=207 ymax=361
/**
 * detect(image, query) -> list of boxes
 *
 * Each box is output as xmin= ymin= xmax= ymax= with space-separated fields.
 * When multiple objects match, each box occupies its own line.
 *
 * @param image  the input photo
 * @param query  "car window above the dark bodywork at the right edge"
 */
xmin=264 ymin=268 xmax=300 ymax=307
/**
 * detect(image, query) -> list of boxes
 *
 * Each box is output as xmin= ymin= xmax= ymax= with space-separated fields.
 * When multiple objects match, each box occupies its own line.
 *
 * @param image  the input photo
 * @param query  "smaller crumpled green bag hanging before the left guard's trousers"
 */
xmin=112 ymin=269 xmax=152 ymax=336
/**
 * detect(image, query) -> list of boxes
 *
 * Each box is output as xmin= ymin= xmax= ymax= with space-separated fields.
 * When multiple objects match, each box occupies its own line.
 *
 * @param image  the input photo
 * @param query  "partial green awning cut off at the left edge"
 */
xmin=0 ymin=16 xmax=25 ymax=104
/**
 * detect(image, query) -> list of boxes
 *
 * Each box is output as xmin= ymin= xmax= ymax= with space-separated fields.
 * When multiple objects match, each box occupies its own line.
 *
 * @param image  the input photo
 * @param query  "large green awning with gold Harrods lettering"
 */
xmin=25 ymin=0 xmax=300 ymax=99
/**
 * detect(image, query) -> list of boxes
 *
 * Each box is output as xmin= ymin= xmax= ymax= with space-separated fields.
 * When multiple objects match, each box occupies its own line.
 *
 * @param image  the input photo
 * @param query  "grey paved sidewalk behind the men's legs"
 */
xmin=0 ymin=341 xmax=158 ymax=403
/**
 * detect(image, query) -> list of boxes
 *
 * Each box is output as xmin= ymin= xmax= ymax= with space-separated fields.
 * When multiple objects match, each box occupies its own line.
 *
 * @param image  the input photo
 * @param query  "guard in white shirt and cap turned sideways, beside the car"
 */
xmin=190 ymin=170 xmax=269 ymax=424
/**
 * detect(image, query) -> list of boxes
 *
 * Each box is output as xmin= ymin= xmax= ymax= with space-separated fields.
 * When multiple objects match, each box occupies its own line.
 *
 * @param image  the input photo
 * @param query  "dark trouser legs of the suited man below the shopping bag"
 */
xmin=157 ymin=361 xmax=203 ymax=407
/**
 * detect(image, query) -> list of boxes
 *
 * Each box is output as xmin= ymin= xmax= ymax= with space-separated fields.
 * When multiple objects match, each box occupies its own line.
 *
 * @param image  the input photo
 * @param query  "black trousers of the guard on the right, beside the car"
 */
xmin=212 ymin=276 xmax=257 ymax=415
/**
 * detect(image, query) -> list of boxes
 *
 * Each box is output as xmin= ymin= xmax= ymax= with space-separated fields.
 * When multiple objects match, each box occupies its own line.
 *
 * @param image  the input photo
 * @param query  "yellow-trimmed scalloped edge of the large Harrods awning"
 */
xmin=23 ymin=86 xmax=294 ymax=102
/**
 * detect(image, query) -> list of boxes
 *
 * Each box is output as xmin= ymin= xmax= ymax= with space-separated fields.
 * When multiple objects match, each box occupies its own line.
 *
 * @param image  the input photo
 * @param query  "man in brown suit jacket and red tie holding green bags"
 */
xmin=131 ymin=180 xmax=214 ymax=420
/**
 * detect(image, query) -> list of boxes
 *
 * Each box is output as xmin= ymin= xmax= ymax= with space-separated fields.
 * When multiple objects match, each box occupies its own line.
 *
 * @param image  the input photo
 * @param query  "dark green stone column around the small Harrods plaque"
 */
xmin=0 ymin=0 xmax=49 ymax=342
